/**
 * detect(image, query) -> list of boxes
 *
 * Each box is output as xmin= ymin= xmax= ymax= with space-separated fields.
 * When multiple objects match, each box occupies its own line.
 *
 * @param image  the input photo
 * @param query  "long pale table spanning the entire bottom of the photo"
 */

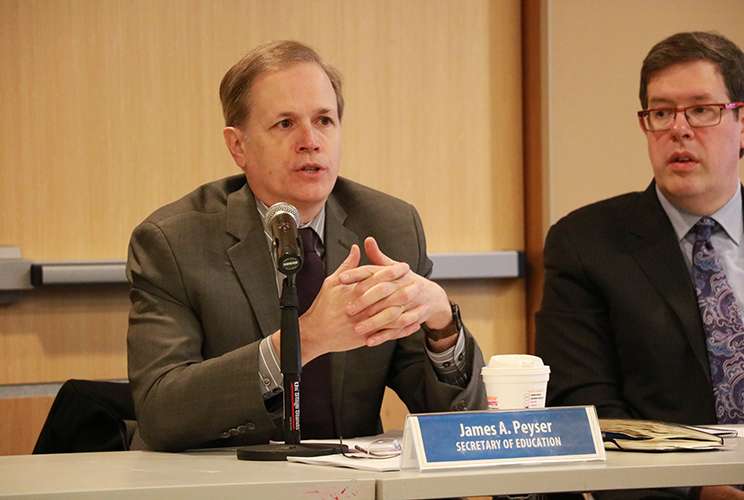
xmin=0 ymin=438 xmax=744 ymax=500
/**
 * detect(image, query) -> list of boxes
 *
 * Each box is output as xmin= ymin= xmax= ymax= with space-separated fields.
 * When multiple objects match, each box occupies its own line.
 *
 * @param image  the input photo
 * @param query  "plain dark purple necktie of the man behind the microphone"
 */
xmin=296 ymin=227 xmax=336 ymax=439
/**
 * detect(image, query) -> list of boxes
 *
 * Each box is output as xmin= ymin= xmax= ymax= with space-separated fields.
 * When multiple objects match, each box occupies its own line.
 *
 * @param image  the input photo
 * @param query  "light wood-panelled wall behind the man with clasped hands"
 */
xmin=0 ymin=0 xmax=525 ymax=454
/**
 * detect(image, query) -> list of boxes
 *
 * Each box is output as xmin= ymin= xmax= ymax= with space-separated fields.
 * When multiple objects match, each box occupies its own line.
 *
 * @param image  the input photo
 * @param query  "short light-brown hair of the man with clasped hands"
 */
xmin=220 ymin=40 xmax=344 ymax=127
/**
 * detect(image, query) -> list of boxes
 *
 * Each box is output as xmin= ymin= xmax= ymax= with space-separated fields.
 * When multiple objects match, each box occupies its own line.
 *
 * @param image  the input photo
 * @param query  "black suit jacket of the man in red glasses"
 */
xmin=535 ymin=183 xmax=716 ymax=424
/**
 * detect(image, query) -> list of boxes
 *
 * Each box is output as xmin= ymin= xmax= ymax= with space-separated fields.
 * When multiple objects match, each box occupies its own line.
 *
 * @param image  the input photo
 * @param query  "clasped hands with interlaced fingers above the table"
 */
xmin=294 ymin=237 xmax=456 ymax=364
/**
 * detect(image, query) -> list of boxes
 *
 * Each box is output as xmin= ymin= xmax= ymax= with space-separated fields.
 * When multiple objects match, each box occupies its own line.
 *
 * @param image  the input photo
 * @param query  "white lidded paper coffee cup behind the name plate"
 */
xmin=481 ymin=354 xmax=550 ymax=410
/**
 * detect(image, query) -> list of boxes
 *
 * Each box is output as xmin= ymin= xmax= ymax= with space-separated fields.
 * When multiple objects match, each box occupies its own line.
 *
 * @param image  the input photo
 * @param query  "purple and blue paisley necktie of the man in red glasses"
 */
xmin=692 ymin=217 xmax=744 ymax=424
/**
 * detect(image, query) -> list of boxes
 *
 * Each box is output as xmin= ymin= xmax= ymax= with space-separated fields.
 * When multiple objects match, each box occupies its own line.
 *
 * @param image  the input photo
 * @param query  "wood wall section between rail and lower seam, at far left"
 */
xmin=0 ymin=287 xmax=129 ymax=384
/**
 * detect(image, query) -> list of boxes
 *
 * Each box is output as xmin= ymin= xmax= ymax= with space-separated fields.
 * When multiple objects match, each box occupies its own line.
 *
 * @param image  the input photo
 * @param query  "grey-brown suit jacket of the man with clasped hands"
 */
xmin=127 ymin=175 xmax=486 ymax=450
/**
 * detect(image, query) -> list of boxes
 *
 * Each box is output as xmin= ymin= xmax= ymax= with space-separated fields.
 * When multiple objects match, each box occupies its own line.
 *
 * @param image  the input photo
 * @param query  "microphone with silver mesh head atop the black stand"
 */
xmin=264 ymin=201 xmax=303 ymax=276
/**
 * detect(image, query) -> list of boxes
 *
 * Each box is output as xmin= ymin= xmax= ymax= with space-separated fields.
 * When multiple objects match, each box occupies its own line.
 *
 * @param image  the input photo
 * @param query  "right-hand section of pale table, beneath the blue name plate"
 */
xmin=377 ymin=437 xmax=744 ymax=500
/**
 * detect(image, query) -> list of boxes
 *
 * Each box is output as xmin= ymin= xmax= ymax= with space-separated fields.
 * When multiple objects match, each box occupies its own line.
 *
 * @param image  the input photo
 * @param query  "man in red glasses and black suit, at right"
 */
xmin=535 ymin=33 xmax=744 ymax=498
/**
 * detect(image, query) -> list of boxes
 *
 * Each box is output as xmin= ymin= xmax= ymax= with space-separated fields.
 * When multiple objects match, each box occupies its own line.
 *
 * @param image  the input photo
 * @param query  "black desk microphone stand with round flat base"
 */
xmin=238 ymin=268 xmax=346 ymax=461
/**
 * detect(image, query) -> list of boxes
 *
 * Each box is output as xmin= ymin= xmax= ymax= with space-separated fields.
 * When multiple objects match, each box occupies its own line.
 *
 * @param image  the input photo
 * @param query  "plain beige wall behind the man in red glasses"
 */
xmin=543 ymin=0 xmax=744 ymax=225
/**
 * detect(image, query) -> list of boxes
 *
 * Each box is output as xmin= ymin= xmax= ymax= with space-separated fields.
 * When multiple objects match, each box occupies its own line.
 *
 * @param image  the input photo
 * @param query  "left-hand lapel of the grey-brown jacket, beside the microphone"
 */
xmin=227 ymin=183 xmax=281 ymax=337
